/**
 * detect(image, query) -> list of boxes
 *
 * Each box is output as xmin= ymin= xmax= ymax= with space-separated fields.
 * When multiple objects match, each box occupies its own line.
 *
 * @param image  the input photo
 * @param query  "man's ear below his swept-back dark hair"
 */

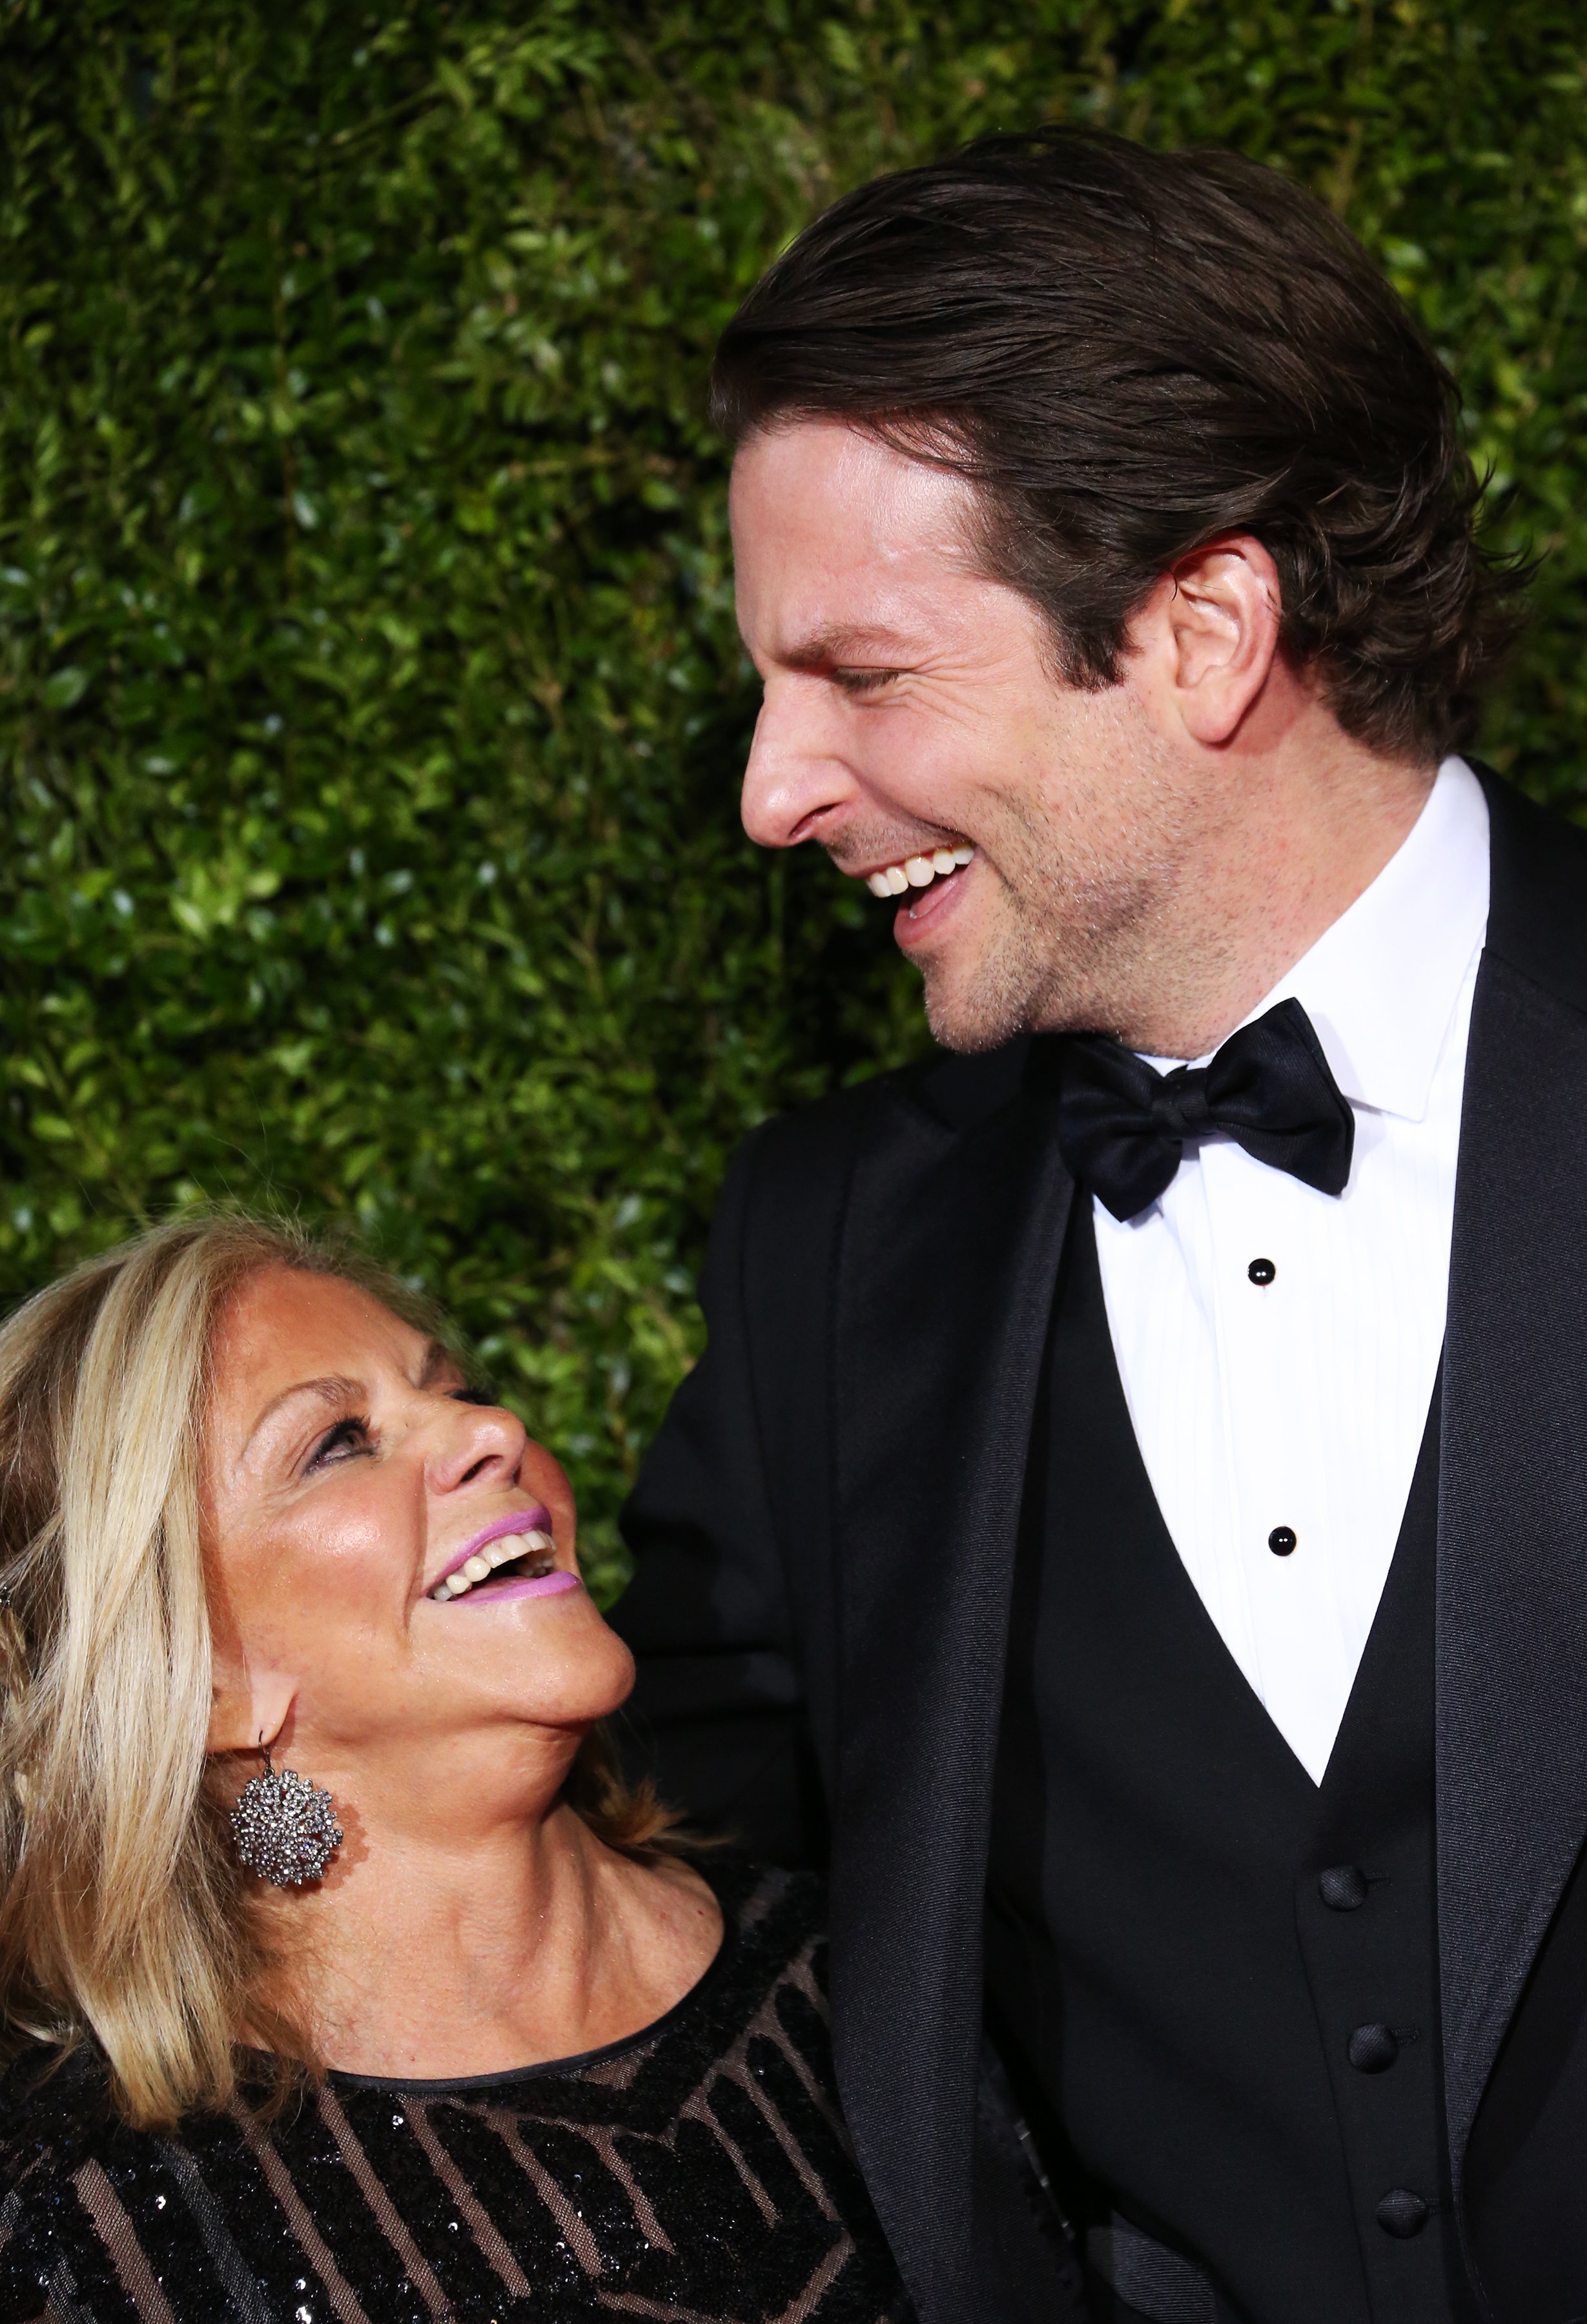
xmin=1132 ymin=532 xmax=1283 ymax=748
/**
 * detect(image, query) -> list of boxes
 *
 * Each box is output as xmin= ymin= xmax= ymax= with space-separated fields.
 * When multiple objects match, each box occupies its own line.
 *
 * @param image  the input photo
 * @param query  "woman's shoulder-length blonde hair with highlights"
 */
xmin=0 ymin=1216 xmax=671 ymax=2129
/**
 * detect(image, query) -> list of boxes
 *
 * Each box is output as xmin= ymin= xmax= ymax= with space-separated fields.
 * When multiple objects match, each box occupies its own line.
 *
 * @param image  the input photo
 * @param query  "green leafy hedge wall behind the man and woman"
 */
xmin=0 ymin=0 xmax=1587 ymax=1587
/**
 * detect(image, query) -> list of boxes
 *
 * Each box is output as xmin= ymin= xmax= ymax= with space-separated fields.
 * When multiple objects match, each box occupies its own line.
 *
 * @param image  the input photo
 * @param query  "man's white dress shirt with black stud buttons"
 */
xmin=1094 ymin=758 xmax=1487 ymax=1782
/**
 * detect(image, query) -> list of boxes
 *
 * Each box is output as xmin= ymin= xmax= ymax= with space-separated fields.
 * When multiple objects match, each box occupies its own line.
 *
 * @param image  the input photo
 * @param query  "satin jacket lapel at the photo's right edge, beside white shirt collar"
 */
xmin=1439 ymin=788 xmax=1587 ymax=2192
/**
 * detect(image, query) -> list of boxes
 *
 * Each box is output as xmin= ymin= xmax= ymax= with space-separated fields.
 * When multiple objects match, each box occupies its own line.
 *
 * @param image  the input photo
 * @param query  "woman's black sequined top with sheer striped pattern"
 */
xmin=0 ymin=1864 xmax=908 ymax=2324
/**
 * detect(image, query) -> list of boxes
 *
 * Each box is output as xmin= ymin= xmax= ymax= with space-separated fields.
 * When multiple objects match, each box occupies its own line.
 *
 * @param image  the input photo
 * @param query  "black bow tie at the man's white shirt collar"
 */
xmin=1057 ymin=1002 xmax=1355 ymax=1218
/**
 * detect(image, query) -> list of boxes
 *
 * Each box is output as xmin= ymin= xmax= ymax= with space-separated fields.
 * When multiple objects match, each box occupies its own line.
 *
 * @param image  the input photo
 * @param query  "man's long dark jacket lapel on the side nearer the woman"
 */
xmin=832 ymin=1055 xmax=1071 ymax=2324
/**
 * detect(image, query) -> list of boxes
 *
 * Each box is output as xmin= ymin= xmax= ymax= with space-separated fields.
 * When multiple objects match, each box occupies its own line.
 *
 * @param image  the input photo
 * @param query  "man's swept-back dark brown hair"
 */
xmin=711 ymin=130 xmax=1517 ymax=758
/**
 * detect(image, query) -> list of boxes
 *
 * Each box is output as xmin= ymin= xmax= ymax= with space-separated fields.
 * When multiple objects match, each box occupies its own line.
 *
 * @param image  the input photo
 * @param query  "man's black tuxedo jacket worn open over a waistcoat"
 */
xmin=616 ymin=781 xmax=1587 ymax=2324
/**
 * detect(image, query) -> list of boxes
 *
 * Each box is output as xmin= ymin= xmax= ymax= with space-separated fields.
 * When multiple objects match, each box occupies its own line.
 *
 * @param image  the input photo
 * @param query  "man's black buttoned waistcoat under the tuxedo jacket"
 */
xmin=988 ymin=1201 xmax=1468 ymax=2324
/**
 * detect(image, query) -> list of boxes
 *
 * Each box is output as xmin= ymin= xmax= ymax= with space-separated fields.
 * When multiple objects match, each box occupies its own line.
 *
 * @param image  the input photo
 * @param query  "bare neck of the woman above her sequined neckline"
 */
xmin=251 ymin=1806 xmax=722 ymax=2080
